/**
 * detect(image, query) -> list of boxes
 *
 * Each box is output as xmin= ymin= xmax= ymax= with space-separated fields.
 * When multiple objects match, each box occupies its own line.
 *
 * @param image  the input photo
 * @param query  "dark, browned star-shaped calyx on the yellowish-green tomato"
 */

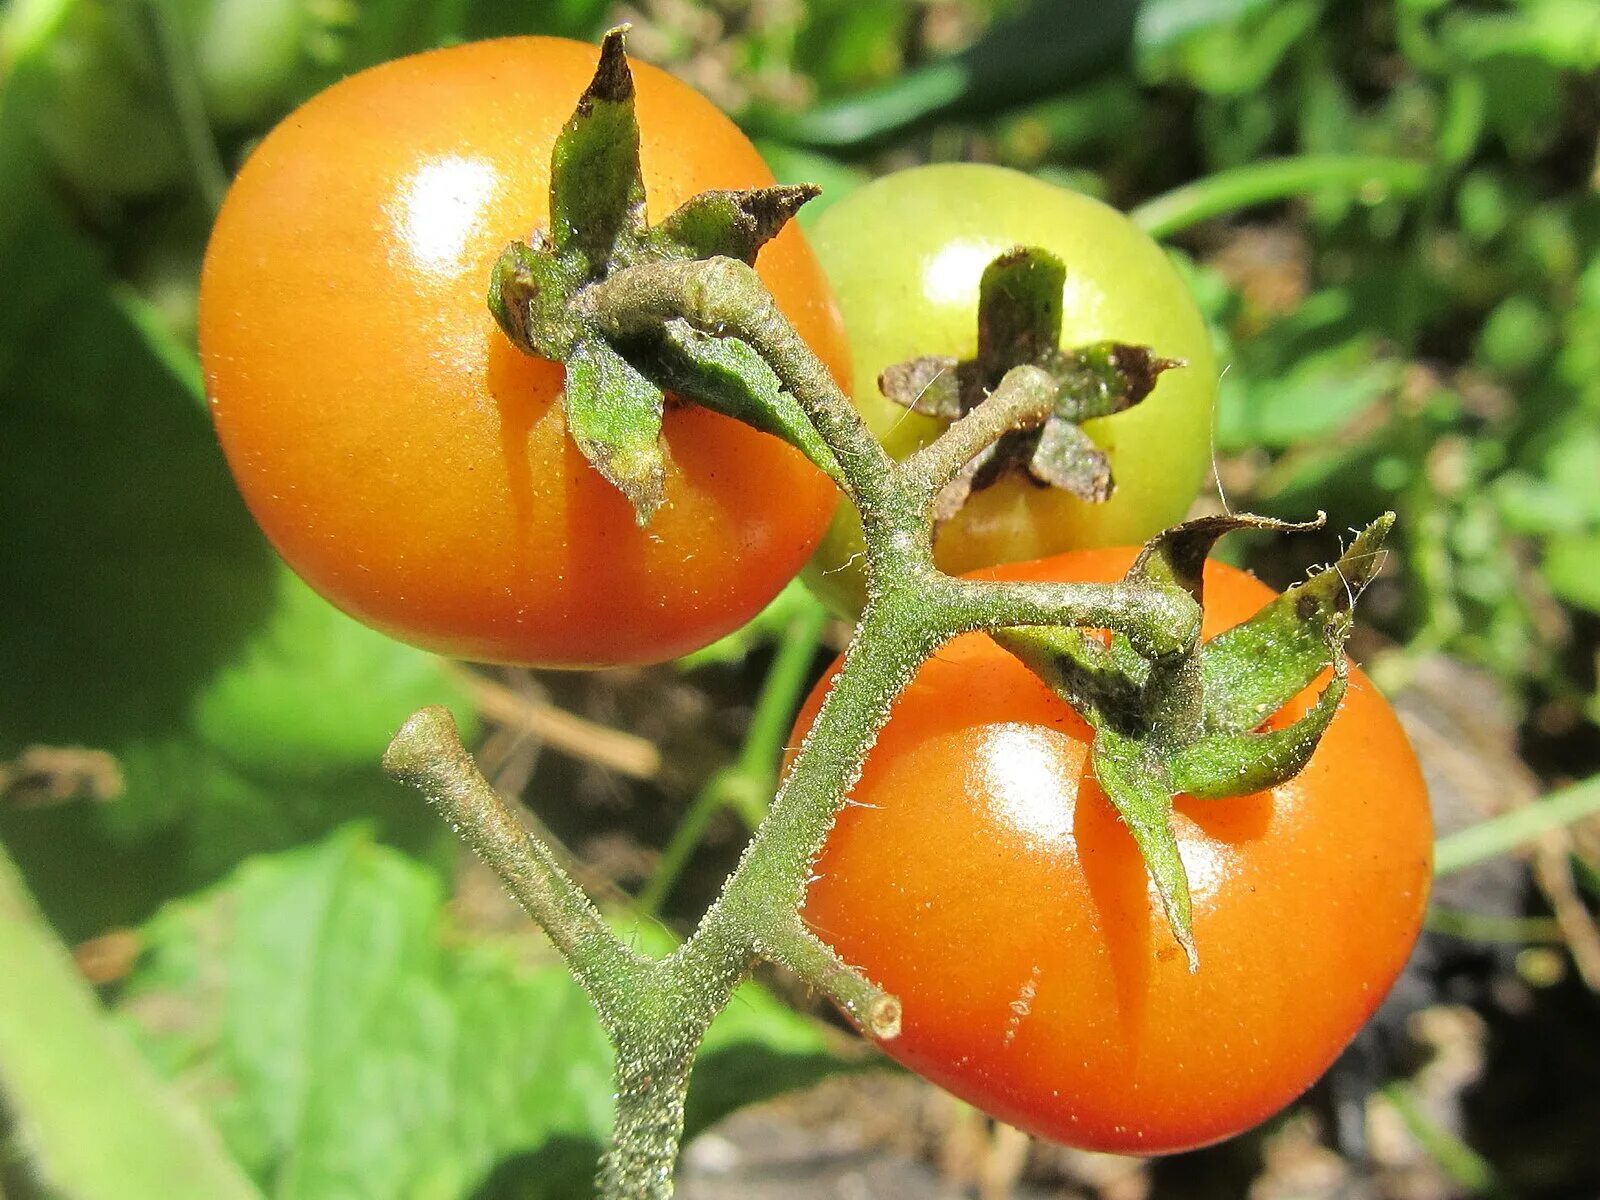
xmin=878 ymin=246 xmax=1184 ymax=522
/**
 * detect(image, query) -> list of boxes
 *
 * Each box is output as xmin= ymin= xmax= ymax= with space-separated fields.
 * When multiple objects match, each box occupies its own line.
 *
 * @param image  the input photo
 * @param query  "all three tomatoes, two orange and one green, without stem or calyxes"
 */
xmin=200 ymin=38 xmax=1430 ymax=1152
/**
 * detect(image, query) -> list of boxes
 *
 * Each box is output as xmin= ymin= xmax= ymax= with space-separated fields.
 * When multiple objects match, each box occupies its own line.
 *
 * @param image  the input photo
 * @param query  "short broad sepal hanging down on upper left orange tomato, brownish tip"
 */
xmin=563 ymin=336 xmax=666 ymax=526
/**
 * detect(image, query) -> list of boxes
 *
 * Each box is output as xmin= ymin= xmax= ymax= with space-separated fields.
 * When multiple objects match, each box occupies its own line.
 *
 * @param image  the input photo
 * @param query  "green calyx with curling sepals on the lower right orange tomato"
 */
xmin=992 ymin=514 xmax=1394 ymax=971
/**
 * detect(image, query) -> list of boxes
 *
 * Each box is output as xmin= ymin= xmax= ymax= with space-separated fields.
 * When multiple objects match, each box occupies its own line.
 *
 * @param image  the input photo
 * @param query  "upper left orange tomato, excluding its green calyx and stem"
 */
xmin=200 ymin=37 xmax=848 ymax=666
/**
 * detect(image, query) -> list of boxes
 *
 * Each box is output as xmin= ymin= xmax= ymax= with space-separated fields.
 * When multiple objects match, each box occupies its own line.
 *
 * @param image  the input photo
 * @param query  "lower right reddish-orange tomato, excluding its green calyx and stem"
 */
xmin=797 ymin=549 xmax=1432 ymax=1154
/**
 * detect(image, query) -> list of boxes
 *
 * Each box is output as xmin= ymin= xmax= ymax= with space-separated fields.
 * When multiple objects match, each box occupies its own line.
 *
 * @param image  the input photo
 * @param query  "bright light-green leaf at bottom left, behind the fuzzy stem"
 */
xmin=118 ymin=832 xmax=837 ymax=1200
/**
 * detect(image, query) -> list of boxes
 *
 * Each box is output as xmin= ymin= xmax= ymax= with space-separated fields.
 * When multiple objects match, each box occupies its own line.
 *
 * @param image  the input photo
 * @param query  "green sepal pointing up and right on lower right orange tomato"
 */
xmin=1200 ymin=512 xmax=1394 ymax=733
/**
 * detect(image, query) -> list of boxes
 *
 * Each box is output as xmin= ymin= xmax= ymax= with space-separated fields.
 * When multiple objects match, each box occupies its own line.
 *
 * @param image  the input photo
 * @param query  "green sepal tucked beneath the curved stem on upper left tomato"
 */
xmin=642 ymin=320 xmax=845 ymax=486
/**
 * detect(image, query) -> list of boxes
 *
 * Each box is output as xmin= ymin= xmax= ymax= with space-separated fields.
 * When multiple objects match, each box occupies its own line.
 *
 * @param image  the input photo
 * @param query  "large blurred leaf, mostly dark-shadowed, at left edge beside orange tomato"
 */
xmin=0 ymin=124 xmax=467 ymax=938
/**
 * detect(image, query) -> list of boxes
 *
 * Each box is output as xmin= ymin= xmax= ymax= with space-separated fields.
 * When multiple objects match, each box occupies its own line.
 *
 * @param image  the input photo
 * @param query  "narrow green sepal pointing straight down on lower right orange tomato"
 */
xmin=1091 ymin=726 xmax=1200 ymax=974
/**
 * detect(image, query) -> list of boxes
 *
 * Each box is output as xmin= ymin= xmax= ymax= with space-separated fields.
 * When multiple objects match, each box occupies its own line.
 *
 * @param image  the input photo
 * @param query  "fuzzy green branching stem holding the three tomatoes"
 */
xmin=386 ymin=241 xmax=1200 ymax=1198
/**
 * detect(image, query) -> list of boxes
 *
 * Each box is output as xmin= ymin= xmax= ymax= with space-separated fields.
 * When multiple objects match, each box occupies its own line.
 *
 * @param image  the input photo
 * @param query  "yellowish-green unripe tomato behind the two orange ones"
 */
xmin=805 ymin=163 xmax=1216 ymax=616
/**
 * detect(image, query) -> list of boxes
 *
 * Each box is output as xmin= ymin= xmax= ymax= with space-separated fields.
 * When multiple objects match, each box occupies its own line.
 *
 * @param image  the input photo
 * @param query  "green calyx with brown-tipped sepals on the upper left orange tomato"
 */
xmin=488 ymin=26 xmax=838 ymax=525
